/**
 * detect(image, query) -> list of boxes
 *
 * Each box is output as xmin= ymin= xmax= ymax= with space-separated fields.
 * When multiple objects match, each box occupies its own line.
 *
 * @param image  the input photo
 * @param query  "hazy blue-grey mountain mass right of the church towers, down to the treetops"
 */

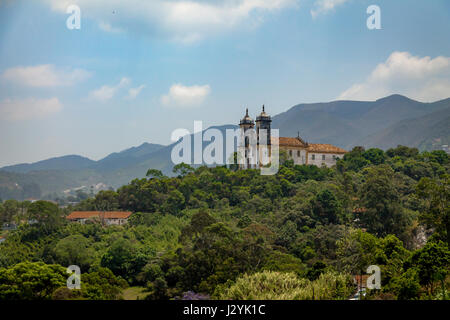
xmin=272 ymin=95 xmax=450 ymax=150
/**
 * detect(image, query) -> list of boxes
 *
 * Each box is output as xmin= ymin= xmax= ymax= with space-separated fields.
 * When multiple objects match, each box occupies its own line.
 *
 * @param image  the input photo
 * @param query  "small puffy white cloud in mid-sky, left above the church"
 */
xmin=161 ymin=84 xmax=211 ymax=107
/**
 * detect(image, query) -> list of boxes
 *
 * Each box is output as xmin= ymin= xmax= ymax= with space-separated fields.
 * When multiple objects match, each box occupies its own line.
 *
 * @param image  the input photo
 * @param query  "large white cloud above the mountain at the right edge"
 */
xmin=338 ymin=51 xmax=450 ymax=101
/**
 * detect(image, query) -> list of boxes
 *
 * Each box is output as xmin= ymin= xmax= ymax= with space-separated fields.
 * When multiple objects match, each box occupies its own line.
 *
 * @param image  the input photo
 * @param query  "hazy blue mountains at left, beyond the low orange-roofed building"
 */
xmin=0 ymin=143 xmax=165 ymax=199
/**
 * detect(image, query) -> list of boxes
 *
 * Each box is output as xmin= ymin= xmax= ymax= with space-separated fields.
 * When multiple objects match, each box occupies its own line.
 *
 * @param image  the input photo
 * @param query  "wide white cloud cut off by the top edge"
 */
xmin=43 ymin=0 xmax=299 ymax=43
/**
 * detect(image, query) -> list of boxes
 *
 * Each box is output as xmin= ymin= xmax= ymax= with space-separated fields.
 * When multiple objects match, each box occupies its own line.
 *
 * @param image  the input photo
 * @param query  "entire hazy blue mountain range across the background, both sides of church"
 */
xmin=0 ymin=95 xmax=450 ymax=199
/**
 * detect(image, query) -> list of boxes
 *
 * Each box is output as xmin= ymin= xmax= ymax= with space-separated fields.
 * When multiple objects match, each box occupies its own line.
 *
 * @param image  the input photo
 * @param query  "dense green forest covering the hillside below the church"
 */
xmin=0 ymin=146 xmax=450 ymax=300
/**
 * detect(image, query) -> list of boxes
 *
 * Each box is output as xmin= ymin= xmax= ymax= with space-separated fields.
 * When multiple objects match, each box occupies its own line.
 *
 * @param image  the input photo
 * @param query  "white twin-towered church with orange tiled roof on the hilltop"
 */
xmin=239 ymin=106 xmax=347 ymax=169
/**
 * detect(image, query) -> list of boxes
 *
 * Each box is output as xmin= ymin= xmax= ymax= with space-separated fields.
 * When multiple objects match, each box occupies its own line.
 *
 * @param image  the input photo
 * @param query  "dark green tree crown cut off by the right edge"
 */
xmin=416 ymin=174 xmax=450 ymax=248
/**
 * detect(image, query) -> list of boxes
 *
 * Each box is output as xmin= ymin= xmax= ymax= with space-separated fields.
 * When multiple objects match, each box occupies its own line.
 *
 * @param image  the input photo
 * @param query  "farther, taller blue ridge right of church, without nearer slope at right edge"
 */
xmin=272 ymin=95 xmax=450 ymax=149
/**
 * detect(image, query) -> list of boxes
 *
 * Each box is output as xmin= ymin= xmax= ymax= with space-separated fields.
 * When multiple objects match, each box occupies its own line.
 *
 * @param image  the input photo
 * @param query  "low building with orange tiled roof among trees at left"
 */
xmin=66 ymin=211 xmax=131 ymax=225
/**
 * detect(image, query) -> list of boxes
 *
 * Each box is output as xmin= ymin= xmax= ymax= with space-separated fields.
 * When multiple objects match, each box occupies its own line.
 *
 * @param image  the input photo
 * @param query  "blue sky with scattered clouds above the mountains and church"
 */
xmin=0 ymin=0 xmax=450 ymax=167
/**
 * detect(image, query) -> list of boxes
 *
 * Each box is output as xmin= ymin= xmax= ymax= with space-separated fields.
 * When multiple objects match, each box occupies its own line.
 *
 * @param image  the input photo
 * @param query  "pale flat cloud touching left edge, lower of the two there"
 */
xmin=0 ymin=98 xmax=62 ymax=121
